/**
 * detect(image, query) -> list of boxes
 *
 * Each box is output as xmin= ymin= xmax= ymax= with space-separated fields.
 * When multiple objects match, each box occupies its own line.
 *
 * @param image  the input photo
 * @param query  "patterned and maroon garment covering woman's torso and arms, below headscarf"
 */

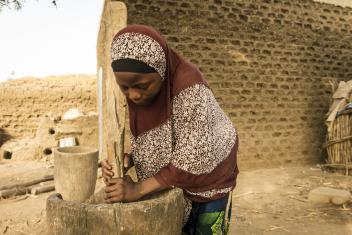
xmin=131 ymin=84 xmax=238 ymax=220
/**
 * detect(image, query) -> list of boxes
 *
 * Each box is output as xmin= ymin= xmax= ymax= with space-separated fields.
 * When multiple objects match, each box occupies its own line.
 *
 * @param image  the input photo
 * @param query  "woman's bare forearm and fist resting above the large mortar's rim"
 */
xmin=105 ymin=176 xmax=170 ymax=203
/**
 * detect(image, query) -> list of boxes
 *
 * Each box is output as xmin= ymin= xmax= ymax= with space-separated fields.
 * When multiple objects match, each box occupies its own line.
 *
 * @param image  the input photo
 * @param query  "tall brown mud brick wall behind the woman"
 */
xmin=124 ymin=0 xmax=352 ymax=169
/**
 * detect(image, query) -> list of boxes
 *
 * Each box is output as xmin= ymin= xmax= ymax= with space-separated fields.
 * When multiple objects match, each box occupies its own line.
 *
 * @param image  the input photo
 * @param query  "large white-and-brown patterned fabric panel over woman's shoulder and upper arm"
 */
xmin=171 ymin=85 xmax=236 ymax=175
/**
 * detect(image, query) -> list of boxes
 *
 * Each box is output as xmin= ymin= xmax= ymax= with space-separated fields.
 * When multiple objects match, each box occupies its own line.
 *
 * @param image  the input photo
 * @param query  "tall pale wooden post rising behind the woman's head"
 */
xmin=97 ymin=0 xmax=127 ymax=163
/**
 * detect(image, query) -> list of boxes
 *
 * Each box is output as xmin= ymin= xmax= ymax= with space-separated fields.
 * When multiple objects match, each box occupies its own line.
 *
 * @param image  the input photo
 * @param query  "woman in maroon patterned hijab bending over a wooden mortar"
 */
xmin=102 ymin=25 xmax=238 ymax=234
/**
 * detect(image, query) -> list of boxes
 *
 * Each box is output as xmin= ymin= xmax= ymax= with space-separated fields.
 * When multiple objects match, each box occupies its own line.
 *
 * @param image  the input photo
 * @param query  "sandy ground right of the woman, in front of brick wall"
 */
xmin=231 ymin=166 xmax=352 ymax=235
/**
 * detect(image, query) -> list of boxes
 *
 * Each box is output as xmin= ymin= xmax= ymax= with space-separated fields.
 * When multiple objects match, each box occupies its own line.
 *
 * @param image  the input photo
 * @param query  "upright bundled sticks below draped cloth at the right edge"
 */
xmin=325 ymin=112 xmax=352 ymax=175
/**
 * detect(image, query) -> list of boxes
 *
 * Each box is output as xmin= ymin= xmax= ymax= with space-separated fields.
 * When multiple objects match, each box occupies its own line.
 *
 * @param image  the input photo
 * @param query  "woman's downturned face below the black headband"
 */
xmin=114 ymin=72 xmax=163 ymax=105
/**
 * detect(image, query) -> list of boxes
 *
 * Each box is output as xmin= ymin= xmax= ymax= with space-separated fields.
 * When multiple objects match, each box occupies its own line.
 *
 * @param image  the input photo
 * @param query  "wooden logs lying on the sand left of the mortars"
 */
xmin=0 ymin=175 xmax=55 ymax=198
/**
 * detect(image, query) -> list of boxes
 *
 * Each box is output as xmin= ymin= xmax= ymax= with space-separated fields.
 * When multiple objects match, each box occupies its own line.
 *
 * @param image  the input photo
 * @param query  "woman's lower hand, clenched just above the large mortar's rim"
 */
xmin=105 ymin=175 xmax=143 ymax=203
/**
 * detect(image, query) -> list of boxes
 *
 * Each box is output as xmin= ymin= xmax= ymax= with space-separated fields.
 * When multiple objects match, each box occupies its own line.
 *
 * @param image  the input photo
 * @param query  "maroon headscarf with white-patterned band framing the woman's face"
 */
xmin=111 ymin=25 xmax=207 ymax=137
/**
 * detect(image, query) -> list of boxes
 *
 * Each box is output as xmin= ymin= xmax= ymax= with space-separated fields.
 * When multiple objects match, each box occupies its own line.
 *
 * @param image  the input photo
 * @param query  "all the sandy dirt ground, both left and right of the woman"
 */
xmin=0 ymin=161 xmax=352 ymax=235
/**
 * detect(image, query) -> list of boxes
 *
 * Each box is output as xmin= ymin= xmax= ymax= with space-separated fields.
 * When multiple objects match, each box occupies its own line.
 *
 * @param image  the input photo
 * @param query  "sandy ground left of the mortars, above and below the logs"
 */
xmin=0 ymin=160 xmax=53 ymax=234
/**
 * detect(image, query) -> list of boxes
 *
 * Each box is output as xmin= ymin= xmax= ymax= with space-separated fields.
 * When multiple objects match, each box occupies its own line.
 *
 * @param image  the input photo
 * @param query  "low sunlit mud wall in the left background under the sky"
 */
xmin=0 ymin=75 xmax=97 ymax=138
